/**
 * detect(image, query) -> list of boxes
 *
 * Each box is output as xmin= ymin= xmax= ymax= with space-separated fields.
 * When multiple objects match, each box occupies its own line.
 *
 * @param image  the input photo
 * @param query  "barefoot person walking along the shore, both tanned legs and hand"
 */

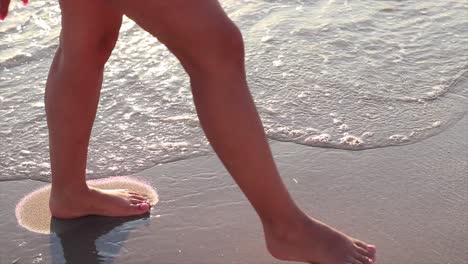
xmin=0 ymin=0 xmax=376 ymax=264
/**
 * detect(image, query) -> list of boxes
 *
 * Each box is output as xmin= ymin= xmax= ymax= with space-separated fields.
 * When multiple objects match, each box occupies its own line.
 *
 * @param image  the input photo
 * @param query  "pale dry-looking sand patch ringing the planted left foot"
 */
xmin=16 ymin=176 xmax=159 ymax=234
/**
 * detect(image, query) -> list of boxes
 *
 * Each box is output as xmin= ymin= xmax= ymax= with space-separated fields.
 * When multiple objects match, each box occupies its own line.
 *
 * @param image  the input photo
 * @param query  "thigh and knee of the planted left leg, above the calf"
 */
xmin=59 ymin=0 xmax=122 ymax=60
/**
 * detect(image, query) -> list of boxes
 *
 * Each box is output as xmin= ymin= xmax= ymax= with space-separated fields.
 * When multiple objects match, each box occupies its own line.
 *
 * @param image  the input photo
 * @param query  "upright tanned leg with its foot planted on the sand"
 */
xmin=45 ymin=0 xmax=149 ymax=218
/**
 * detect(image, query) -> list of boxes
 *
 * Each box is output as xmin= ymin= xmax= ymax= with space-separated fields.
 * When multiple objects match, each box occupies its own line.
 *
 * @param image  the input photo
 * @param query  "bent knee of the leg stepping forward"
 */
xmin=182 ymin=23 xmax=244 ymax=77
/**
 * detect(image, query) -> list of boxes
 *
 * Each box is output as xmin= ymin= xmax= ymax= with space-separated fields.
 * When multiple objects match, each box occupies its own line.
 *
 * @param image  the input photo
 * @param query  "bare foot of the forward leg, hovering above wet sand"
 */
xmin=264 ymin=218 xmax=376 ymax=264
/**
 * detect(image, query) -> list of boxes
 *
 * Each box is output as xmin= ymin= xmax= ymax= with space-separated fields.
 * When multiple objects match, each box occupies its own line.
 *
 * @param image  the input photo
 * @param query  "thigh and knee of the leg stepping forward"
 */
xmin=109 ymin=0 xmax=242 ymax=68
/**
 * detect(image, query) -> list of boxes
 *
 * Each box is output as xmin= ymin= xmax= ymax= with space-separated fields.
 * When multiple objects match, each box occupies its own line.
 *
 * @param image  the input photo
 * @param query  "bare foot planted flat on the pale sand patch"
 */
xmin=49 ymin=187 xmax=151 ymax=219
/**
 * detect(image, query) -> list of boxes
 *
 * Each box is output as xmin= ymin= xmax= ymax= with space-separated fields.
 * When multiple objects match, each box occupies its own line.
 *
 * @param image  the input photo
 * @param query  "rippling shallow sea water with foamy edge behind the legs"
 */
xmin=0 ymin=0 xmax=468 ymax=181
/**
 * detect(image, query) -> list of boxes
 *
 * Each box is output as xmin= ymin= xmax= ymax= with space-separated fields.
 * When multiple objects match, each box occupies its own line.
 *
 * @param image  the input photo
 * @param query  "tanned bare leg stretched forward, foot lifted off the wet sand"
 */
xmin=113 ymin=0 xmax=375 ymax=264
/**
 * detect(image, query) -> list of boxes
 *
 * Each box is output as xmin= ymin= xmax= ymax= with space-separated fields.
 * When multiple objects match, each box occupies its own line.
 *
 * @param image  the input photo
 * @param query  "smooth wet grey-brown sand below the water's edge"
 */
xmin=0 ymin=117 xmax=468 ymax=264
